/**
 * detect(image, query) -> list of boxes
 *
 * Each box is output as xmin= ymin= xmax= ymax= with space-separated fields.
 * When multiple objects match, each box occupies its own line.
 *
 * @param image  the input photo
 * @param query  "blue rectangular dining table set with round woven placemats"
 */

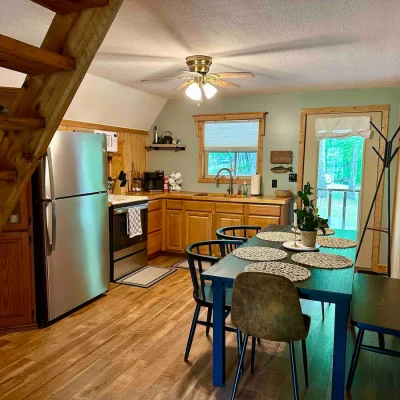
xmin=202 ymin=225 xmax=356 ymax=400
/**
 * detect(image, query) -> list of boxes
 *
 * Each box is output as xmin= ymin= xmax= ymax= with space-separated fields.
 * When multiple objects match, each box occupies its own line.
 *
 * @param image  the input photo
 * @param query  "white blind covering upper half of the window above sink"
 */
xmin=204 ymin=120 xmax=259 ymax=151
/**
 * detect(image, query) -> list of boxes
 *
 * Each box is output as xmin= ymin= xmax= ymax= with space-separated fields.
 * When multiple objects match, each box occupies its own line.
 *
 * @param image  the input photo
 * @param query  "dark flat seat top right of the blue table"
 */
xmin=351 ymin=273 xmax=400 ymax=334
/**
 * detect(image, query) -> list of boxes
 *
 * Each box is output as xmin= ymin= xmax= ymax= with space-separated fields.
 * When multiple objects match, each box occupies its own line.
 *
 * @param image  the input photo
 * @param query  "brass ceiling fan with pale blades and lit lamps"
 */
xmin=142 ymin=55 xmax=254 ymax=105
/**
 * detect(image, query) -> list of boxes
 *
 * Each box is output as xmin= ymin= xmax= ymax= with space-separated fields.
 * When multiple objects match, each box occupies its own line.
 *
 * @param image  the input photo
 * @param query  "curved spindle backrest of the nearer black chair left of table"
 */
xmin=185 ymin=240 xmax=243 ymax=300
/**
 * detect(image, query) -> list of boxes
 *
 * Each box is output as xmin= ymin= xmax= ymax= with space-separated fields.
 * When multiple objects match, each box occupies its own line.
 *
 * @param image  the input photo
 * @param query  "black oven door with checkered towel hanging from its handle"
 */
xmin=113 ymin=203 xmax=148 ymax=261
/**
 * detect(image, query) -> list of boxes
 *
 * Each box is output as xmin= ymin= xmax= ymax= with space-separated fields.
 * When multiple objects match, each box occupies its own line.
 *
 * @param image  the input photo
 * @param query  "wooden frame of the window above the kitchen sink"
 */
xmin=193 ymin=112 xmax=267 ymax=184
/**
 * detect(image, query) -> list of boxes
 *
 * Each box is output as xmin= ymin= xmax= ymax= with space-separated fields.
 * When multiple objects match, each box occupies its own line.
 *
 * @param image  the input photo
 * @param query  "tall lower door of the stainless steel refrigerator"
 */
xmin=47 ymin=193 xmax=110 ymax=321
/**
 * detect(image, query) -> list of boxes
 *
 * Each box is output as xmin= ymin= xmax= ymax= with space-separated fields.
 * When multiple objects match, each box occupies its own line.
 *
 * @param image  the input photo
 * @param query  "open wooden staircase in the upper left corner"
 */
xmin=0 ymin=0 xmax=123 ymax=231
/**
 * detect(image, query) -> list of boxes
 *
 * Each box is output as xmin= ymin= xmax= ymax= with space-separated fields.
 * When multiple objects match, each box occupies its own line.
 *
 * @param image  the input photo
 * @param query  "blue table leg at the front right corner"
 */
xmin=331 ymin=297 xmax=351 ymax=400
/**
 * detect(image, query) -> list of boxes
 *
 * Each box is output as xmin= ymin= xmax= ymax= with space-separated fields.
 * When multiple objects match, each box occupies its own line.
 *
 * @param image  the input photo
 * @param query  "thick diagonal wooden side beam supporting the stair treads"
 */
xmin=0 ymin=0 xmax=123 ymax=230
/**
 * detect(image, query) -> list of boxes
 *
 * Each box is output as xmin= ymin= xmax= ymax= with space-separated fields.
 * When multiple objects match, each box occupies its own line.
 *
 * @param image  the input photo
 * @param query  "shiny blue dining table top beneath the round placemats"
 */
xmin=202 ymin=225 xmax=356 ymax=296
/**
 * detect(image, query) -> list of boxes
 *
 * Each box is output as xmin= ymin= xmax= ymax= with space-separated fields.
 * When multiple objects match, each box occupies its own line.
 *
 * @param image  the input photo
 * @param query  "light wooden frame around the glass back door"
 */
xmin=297 ymin=104 xmax=390 ymax=272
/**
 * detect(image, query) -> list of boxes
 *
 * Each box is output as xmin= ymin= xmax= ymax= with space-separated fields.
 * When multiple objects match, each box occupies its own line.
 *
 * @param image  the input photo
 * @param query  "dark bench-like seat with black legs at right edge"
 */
xmin=346 ymin=272 xmax=400 ymax=390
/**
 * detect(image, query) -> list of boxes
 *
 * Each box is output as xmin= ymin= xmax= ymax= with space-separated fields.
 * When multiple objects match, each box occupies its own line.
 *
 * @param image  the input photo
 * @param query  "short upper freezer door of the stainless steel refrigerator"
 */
xmin=45 ymin=131 xmax=107 ymax=198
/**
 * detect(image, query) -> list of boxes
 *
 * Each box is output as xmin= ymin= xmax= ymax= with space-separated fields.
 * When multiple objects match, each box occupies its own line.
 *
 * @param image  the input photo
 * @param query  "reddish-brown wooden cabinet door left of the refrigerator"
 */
xmin=0 ymin=232 xmax=35 ymax=327
